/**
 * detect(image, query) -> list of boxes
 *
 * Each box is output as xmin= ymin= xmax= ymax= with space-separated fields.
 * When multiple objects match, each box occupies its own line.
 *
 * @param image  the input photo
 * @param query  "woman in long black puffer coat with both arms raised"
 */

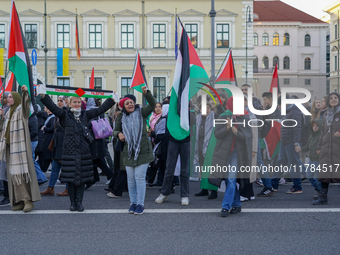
xmin=41 ymin=91 xmax=115 ymax=212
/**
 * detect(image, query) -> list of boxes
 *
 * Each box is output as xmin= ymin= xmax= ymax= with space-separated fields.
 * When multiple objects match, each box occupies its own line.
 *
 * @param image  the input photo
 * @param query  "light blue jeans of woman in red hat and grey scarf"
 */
xmin=125 ymin=163 xmax=149 ymax=206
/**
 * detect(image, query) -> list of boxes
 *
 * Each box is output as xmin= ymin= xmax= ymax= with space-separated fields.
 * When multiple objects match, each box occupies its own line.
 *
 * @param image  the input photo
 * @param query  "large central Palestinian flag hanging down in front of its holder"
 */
xmin=167 ymin=25 xmax=209 ymax=140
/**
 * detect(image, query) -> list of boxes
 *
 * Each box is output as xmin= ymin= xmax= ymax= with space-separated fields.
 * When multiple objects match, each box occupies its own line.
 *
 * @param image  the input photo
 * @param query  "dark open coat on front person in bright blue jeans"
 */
xmin=209 ymin=114 xmax=252 ymax=189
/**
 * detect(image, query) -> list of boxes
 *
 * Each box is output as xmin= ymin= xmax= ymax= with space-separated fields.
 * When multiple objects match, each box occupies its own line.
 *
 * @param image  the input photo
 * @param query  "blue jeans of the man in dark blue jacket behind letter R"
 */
xmin=272 ymin=143 xmax=306 ymax=190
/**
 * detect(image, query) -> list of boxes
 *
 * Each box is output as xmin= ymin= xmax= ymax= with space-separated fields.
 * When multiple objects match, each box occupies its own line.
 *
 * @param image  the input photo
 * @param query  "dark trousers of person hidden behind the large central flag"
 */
xmin=161 ymin=140 xmax=190 ymax=197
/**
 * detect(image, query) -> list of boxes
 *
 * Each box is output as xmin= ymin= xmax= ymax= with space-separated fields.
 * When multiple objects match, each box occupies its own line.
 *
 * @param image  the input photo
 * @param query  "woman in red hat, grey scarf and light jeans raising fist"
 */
xmin=113 ymin=86 xmax=156 ymax=214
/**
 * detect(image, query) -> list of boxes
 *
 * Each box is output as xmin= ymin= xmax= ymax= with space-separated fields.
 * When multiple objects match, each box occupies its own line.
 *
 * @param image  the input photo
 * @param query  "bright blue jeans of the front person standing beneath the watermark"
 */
xmin=222 ymin=148 xmax=241 ymax=211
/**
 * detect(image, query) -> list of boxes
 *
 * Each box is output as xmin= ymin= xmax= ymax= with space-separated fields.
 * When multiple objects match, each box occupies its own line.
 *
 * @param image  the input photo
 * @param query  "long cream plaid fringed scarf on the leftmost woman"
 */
xmin=0 ymin=105 xmax=32 ymax=185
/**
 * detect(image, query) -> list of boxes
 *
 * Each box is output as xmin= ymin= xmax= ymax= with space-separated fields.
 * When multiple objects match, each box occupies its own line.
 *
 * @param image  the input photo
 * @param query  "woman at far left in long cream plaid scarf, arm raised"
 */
xmin=0 ymin=86 xmax=41 ymax=212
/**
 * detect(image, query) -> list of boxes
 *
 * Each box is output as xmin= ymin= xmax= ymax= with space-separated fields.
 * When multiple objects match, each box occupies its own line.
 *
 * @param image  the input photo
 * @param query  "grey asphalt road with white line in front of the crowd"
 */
xmin=0 ymin=177 xmax=340 ymax=254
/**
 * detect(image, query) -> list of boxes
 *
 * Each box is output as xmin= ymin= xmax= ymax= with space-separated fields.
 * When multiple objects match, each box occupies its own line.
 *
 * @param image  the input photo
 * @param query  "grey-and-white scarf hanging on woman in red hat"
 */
xmin=122 ymin=106 xmax=143 ymax=160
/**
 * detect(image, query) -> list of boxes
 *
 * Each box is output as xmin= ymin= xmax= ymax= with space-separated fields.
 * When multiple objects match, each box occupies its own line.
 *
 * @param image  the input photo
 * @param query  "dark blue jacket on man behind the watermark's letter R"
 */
xmin=281 ymin=105 xmax=302 ymax=144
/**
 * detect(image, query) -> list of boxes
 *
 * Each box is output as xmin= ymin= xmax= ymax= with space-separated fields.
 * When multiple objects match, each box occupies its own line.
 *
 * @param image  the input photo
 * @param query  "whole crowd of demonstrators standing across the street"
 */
xmin=0 ymin=81 xmax=340 ymax=217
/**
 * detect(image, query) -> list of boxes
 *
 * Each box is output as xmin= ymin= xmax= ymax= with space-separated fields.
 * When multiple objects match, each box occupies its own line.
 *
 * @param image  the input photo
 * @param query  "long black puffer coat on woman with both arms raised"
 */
xmin=41 ymin=95 xmax=114 ymax=185
